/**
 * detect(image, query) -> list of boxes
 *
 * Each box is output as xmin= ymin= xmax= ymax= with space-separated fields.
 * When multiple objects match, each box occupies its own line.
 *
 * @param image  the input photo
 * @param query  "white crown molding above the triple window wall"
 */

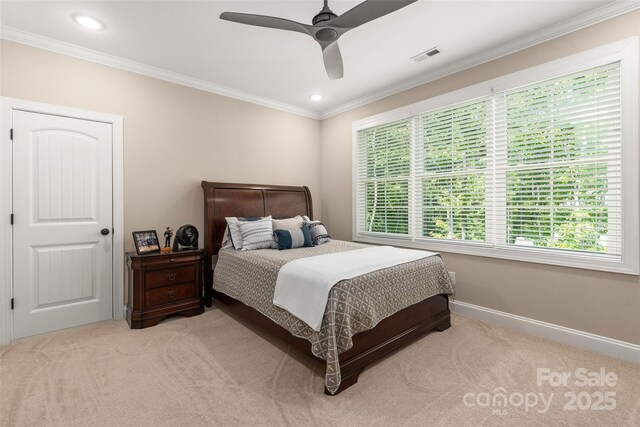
xmin=320 ymin=0 xmax=640 ymax=120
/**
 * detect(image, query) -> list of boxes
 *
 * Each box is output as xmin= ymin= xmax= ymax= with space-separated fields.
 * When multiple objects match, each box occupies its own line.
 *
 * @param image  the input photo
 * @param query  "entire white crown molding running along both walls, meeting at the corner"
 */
xmin=0 ymin=0 xmax=640 ymax=120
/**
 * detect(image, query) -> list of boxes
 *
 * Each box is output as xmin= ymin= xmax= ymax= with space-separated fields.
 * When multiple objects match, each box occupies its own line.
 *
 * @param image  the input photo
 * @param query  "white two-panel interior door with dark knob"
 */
xmin=12 ymin=110 xmax=113 ymax=339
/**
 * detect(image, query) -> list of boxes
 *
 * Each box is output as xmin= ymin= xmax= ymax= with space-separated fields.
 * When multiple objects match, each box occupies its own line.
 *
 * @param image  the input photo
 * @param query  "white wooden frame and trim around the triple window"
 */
xmin=352 ymin=37 xmax=640 ymax=275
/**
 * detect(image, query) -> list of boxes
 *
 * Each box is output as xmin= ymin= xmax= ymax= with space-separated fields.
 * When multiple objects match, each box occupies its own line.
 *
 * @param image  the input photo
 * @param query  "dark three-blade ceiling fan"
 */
xmin=220 ymin=0 xmax=417 ymax=80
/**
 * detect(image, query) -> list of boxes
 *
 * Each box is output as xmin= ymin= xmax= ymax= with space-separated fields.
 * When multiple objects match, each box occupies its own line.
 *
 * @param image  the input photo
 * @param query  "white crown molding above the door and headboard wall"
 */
xmin=0 ymin=25 xmax=320 ymax=120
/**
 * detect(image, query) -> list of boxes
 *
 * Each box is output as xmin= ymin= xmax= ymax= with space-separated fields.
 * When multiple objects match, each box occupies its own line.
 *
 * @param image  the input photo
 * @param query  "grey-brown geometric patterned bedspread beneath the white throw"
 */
xmin=213 ymin=240 xmax=454 ymax=393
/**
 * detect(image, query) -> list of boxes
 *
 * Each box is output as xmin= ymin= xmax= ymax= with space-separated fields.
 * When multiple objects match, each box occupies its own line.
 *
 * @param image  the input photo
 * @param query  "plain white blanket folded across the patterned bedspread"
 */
xmin=273 ymin=246 xmax=437 ymax=331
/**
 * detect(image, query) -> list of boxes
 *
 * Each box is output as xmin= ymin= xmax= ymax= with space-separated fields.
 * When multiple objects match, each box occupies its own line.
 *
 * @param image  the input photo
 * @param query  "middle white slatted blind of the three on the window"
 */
xmin=414 ymin=99 xmax=488 ymax=241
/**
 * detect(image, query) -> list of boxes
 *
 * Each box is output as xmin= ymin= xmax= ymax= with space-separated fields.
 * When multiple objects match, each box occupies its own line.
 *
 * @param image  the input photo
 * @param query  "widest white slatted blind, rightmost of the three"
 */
xmin=494 ymin=62 xmax=622 ymax=255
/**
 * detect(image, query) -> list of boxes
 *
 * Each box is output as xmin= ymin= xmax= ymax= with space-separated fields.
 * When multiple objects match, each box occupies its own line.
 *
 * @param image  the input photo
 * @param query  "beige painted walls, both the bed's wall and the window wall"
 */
xmin=0 ymin=11 xmax=640 ymax=344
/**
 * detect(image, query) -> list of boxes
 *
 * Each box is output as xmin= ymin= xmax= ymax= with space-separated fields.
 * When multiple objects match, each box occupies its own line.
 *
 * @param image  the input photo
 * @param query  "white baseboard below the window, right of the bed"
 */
xmin=450 ymin=301 xmax=640 ymax=363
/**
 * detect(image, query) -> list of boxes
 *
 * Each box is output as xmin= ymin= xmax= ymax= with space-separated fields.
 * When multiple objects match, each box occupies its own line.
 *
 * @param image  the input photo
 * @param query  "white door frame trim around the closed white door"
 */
xmin=0 ymin=97 xmax=124 ymax=345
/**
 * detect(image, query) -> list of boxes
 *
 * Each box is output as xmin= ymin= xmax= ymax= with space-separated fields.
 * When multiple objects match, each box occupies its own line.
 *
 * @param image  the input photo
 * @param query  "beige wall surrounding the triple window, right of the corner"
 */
xmin=320 ymin=11 xmax=640 ymax=344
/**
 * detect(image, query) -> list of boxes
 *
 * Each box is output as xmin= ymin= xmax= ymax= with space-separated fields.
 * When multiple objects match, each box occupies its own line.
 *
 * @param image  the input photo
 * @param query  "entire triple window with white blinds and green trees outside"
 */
xmin=354 ymin=41 xmax=639 ymax=274
